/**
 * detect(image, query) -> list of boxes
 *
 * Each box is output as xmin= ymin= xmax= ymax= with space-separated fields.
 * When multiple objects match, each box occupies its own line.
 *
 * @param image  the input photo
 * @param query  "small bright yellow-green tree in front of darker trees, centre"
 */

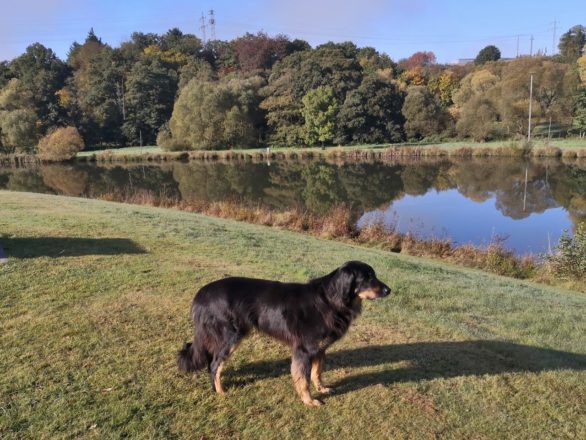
xmin=301 ymin=87 xmax=338 ymax=145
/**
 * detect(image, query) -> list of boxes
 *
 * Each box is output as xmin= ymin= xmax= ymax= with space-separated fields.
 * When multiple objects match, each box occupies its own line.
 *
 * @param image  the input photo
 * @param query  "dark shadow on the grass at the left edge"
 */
xmin=0 ymin=237 xmax=146 ymax=258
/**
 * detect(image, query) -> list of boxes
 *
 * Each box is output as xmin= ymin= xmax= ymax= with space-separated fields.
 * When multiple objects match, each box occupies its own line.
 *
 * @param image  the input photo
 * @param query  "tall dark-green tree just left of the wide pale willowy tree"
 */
xmin=122 ymin=58 xmax=177 ymax=145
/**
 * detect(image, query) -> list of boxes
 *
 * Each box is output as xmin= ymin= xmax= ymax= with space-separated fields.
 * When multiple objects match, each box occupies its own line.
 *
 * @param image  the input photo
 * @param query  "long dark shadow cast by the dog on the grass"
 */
xmin=225 ymin=340 xmax=586 ymax=394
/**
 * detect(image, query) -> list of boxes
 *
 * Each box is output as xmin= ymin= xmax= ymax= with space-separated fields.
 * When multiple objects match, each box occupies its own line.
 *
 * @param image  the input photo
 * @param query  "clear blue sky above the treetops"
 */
xmin=0 ymin=0 xmax=586 ymax=62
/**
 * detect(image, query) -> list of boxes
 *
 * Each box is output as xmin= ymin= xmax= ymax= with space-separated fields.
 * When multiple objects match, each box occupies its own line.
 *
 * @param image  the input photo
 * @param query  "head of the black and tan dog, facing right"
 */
xmin=328 ymin=261 xmax=391 ymax=304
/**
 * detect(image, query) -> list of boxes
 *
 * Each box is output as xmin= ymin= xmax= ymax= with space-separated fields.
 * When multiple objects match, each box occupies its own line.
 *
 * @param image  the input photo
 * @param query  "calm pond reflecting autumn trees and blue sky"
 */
xmin=0 ymin=158 xmax=586 ymax=254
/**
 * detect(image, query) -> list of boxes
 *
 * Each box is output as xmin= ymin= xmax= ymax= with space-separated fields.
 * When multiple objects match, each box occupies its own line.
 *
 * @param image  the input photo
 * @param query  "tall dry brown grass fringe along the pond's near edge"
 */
xmin=98 ymin=187 xmax=540 ymax=284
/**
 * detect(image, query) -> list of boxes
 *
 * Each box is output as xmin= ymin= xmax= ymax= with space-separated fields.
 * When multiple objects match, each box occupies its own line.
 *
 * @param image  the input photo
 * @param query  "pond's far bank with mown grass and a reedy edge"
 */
xmin=72 ymin=139 xmax=586 ymax=162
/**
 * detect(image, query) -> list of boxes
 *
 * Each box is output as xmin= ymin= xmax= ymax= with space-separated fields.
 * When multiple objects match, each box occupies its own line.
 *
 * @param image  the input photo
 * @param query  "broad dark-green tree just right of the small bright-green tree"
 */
xmin=336 ymin=75 xmax=405 ymax=144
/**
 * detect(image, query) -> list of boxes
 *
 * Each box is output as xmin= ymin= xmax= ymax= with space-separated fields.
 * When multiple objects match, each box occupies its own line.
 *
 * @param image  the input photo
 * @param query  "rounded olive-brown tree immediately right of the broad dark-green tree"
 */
xmin=402 ymin=86 xmax=450 ymax=139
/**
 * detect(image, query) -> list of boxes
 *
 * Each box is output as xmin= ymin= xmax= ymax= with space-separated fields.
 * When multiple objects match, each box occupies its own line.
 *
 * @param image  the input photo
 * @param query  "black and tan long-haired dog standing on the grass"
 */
xmin=177 ymin=261 xmax=391 ymax=406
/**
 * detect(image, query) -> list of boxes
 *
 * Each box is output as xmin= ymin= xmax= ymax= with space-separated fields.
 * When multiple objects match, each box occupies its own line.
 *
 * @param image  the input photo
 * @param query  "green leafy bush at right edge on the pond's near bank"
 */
xmin=546 ymin=223 xmax=586 ymax=279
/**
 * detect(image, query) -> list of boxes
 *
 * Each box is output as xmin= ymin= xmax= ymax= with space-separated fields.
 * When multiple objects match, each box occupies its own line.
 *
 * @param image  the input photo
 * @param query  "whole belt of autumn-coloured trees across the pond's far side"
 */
xmin=0 ymin=26 xmax=586 ymax=155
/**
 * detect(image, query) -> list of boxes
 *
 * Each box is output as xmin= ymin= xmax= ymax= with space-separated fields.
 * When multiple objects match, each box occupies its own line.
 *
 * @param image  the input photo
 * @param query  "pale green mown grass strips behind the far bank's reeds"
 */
xmin=77 ymin=138 xmax=586 ymax=157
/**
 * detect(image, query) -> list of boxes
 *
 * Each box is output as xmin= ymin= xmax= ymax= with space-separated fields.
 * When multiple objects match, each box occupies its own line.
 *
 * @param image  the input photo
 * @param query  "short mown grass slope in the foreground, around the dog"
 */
xmin=0 ymin=191 xmax=586 ymax=439
